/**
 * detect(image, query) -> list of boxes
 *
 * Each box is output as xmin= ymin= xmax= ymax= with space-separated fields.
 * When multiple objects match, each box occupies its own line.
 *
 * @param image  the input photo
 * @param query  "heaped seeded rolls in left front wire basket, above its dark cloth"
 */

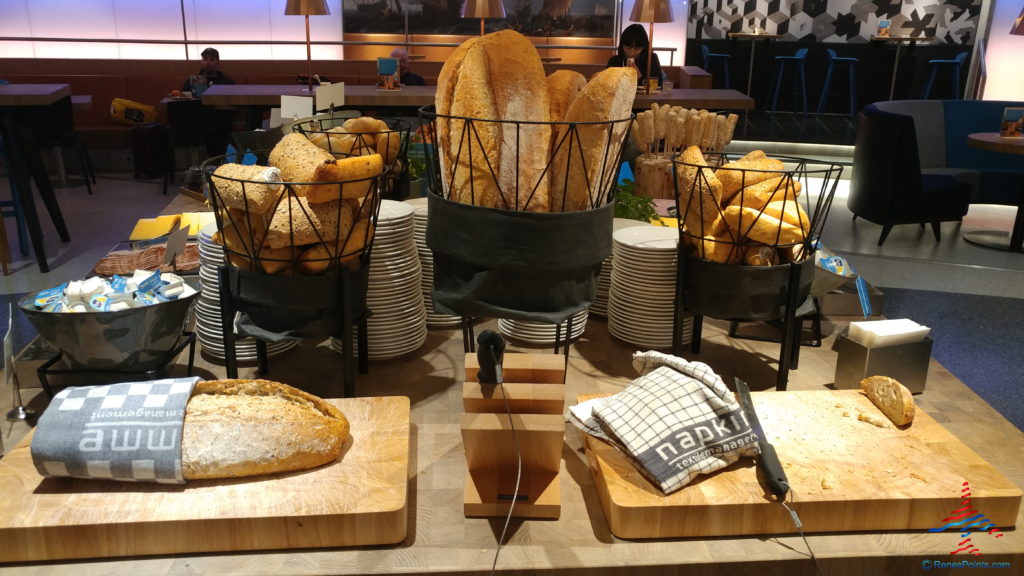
xmin=204 ymin=132 xmax=387 ymax=275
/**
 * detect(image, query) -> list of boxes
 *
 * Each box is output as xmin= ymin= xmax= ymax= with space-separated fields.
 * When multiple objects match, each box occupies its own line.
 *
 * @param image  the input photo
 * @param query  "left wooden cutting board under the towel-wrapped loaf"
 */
xmin=0 ymin=397 xmax=410 ymax=562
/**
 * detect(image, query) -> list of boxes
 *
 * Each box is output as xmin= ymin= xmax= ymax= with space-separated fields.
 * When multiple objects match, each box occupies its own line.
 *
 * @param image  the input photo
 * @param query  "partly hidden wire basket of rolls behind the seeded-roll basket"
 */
xmin=292 ymin=112 xmax=413 ymax=200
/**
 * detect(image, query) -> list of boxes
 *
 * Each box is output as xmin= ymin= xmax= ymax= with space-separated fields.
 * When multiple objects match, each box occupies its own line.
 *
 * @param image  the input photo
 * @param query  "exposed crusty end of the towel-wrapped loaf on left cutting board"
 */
xmin=181 ymin=380 xmax=349 ymax=480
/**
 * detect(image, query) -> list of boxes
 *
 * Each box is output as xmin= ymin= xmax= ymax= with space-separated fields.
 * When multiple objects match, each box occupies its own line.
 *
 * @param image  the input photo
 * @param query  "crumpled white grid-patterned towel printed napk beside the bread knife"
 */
xmin=569 ymin=352 xmax=758 ymax=494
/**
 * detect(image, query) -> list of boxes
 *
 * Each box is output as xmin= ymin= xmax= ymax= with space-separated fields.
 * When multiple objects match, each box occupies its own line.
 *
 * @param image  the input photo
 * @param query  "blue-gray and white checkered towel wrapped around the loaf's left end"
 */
xmin=31 ymin=377 xmax=200 ymax=484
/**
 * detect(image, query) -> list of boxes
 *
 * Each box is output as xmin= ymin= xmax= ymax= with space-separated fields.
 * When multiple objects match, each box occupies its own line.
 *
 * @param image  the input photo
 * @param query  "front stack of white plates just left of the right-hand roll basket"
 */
xmin=608 ymin=225 xmax=693 ymax=348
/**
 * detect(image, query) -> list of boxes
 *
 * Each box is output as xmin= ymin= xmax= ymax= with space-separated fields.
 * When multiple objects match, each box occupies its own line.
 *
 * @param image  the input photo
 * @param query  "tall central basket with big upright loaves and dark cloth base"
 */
xmin=420 ymin=30 xmax=636 ymax=322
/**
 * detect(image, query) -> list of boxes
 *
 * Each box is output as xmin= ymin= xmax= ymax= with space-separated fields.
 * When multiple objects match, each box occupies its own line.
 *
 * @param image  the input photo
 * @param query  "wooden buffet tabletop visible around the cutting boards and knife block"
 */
xmin=0 ymin=264 xmax=1024 ymax=576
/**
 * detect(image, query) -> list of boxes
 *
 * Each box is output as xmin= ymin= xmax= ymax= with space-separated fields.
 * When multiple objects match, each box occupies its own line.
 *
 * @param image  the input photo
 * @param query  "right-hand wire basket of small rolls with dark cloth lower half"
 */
xmin=673 ymin=146 xmax=843 ymax=320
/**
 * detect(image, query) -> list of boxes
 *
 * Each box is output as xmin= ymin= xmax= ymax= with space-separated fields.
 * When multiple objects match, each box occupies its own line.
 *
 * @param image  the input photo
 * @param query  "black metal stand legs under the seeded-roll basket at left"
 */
xmin=217 ymin=266 xmax=370 ymax=398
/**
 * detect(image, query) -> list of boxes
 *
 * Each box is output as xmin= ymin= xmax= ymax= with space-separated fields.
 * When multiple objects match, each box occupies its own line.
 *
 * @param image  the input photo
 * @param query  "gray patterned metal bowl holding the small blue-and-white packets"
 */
xmin=17 ymin=284 xmax=199 ymax=372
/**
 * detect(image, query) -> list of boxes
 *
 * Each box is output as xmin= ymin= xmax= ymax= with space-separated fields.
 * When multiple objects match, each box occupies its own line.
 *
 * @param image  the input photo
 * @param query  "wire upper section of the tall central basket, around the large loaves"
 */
xmin=419 ymin=106 xmax=633 ymax=212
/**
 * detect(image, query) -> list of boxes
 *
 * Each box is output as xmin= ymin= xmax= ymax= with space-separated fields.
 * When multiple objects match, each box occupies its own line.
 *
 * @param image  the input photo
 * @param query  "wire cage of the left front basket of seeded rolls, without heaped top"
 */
xmin=203 ymin=146 xmax=388 ymax=275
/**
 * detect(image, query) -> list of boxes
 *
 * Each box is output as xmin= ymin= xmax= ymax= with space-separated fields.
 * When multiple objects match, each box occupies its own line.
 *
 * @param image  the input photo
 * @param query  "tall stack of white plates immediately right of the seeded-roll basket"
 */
xmin=331 ymin=200 xmax=427 ymax=360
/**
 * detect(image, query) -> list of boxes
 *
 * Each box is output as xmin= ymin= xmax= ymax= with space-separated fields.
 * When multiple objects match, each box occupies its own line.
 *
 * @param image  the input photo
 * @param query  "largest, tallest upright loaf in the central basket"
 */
xmin=435 ymin=30 xmax=551 ymax=211
